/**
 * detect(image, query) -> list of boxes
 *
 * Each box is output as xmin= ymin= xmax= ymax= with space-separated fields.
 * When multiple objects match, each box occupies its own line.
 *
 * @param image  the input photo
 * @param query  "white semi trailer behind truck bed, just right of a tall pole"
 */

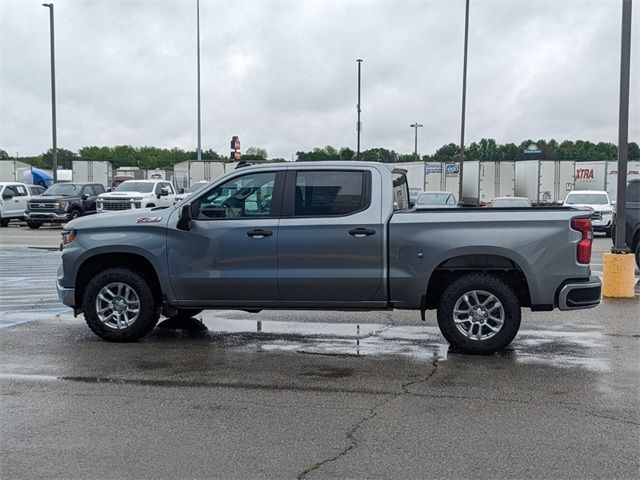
xmin=461 ymin=160 xmax=516 ymax=205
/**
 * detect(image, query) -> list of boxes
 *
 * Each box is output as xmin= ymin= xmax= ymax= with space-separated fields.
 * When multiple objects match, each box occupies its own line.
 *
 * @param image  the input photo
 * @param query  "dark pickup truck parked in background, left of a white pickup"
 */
xmin=24 ymin=183 xmax=105 ymax=230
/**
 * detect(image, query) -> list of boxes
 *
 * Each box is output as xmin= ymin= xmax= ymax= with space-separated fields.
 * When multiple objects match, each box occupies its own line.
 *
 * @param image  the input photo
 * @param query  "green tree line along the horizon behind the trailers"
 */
xmin=0 ymin=138 xmax=640 ymax=170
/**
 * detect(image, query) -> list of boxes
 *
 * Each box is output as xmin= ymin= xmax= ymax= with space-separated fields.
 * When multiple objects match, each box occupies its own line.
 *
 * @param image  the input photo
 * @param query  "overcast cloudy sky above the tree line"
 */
xmin=0 ymin=0 xmax=640 ymax=158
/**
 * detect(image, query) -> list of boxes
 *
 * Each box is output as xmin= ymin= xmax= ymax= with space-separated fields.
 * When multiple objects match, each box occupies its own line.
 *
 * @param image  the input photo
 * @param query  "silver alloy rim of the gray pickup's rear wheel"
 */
xmin=453 ymin=290 xmax=505 ymax=340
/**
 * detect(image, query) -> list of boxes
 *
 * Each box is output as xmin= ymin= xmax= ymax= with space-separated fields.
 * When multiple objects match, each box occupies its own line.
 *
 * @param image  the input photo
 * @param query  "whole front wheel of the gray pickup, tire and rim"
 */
xmin=82 ymin=268 xmax=160 ymax=342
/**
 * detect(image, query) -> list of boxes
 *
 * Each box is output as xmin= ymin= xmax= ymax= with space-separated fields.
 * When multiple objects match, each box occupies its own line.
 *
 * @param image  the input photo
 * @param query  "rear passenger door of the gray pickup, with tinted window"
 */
xmin=278 ymin=170 xmax=385 ymax=303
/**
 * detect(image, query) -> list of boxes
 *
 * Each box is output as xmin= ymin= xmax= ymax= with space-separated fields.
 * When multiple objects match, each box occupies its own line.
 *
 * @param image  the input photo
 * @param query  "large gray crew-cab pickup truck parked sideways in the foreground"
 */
xmin=57 ymin=162 xmax=601 ymax=354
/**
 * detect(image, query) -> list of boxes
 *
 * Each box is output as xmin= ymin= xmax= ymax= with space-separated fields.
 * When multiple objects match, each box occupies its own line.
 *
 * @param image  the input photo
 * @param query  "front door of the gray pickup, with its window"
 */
xmin=167 ymin=172 xmax=284 ymax=306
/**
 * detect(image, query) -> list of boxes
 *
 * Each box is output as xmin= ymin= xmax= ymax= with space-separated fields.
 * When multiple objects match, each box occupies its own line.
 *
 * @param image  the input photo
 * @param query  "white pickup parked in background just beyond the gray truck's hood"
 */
xmin=97 ymin=180 xmax=176 ymax=212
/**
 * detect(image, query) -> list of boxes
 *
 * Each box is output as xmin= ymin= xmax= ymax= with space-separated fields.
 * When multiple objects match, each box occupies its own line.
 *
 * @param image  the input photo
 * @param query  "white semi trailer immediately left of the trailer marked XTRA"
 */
xmin=515 ymin=160 xmax=575 ymax=205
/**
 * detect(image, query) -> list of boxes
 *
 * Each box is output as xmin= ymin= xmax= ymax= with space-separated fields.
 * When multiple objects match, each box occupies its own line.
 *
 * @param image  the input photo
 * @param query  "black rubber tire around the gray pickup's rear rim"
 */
xmin=438 ymin=273 xmax=520 ymax=355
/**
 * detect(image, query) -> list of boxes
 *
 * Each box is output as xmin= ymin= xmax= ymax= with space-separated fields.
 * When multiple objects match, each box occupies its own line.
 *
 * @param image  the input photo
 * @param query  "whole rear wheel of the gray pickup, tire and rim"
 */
xmin=438 ymin=273 xmax=520 ymax=355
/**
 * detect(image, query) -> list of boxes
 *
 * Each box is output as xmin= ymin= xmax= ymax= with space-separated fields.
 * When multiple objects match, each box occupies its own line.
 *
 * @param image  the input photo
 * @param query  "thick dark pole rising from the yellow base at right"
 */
xmin=611 ymin=0 xmax=631 ymax=253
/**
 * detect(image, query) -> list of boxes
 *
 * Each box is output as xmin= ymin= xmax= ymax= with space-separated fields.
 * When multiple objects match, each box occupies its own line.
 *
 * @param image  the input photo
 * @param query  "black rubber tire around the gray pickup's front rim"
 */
xmin=82 ymin=268 xmax=160 ymax=342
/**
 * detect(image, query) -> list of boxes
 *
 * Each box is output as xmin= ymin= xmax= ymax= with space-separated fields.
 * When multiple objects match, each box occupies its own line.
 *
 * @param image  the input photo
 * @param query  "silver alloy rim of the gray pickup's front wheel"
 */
xmin=96 ymin=282 xmax=140 ymax=330
